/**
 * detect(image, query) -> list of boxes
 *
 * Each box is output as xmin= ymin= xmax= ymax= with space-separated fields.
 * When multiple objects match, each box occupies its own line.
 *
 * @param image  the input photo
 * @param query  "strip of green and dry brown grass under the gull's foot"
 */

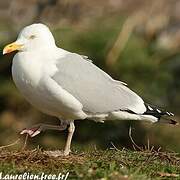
xmin=0 ymin=147 xmax=180 ymax=180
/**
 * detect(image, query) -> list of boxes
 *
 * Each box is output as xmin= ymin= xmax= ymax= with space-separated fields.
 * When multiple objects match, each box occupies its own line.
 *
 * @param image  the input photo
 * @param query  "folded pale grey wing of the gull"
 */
xmin=52 ymin=53 xmax=146 ymax=114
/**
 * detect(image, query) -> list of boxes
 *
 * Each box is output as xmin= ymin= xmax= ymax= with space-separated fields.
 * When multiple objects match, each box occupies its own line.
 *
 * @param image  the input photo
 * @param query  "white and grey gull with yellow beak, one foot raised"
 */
xmin=3 ymin=23 xmax=177 ymax=156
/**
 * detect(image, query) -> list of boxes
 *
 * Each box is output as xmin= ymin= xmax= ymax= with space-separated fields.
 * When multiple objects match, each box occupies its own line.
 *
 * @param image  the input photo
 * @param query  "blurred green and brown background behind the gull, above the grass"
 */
xmin=0 ymin=0 xmax=180 ymax=152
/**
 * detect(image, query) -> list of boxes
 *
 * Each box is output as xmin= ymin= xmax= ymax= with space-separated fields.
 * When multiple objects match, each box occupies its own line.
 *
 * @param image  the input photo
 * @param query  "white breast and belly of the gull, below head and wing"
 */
xmin=12 ymin=52 xmax=86 ymax=119
